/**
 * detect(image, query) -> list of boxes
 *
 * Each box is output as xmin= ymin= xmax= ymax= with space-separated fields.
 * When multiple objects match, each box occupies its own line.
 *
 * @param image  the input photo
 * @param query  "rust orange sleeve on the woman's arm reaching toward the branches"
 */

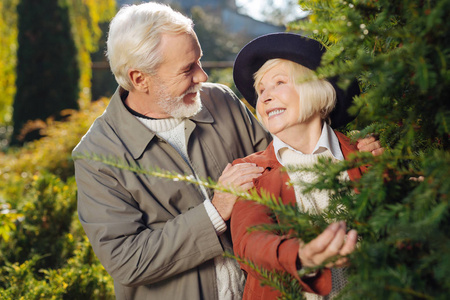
xmin=231 ymin=171 xmax=331 ymax=295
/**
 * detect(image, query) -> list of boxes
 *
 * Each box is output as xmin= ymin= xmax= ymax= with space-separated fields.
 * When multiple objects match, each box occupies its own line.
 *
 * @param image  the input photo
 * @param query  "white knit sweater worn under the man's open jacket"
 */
xmin=136 ymin=116 xmax=245 ymax=300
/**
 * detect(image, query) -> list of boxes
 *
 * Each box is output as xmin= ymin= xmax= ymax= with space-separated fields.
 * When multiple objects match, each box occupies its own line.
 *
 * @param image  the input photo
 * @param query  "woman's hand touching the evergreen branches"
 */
xmin=298 ymin=222 xmax=358 ymax=268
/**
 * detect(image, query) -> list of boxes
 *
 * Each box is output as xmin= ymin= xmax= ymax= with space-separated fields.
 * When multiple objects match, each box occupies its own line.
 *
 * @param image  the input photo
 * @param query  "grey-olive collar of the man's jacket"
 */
xmin=104 ymin=87 xmax=214 ymax=159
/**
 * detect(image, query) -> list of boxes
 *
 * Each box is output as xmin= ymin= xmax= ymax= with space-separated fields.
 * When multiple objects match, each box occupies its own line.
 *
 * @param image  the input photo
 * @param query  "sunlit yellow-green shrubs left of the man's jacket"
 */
xmin=0 ymin=99 xmax=114 ymax=299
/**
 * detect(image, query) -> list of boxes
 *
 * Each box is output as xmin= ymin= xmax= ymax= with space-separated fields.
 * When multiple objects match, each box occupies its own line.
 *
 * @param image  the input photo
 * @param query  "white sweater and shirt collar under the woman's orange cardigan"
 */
xmin=273 ymin=123 xmax=349 ymax=300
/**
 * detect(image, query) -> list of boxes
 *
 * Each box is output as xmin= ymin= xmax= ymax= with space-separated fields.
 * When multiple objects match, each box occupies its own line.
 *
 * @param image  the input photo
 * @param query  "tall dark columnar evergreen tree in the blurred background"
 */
xmin=13 ymin=0 xmax=80 ymax=143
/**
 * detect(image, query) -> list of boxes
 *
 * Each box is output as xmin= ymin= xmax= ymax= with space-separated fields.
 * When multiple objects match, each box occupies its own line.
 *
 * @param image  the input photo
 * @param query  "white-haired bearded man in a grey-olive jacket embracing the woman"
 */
xmin=73 ymin=3 xmax=379 ymax=299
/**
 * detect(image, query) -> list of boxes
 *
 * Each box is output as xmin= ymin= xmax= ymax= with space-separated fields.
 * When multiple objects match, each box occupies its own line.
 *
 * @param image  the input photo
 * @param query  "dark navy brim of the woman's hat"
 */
xmin=233 ymin=32 xmax=360 ymax=128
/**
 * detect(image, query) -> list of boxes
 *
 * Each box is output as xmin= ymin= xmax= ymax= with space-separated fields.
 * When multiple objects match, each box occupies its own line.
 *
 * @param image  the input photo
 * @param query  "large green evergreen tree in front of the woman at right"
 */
xmin=243 ymin=0 xmax=450 ymax=299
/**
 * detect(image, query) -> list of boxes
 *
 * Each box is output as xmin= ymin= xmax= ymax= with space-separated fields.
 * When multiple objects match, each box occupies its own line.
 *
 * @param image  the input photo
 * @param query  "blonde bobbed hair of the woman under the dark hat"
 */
xmin=253 ymin=58 xmax=336 ymax=123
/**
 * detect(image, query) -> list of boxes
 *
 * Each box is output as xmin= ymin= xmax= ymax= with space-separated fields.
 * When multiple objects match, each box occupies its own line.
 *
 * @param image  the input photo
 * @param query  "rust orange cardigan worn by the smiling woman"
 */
xmin=231 ymin=131 xmax=363 ymax=299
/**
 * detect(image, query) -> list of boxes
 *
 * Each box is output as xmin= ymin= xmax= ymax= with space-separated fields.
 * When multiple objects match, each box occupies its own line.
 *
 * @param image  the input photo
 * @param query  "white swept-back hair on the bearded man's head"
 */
xmin=106 ymin=2 xmax=195 ymax=91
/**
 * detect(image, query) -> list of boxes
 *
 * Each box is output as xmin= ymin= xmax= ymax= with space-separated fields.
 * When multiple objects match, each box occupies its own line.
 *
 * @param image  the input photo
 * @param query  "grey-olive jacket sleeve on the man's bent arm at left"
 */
xmin=75 ymin=159 xmax=223 ymax=286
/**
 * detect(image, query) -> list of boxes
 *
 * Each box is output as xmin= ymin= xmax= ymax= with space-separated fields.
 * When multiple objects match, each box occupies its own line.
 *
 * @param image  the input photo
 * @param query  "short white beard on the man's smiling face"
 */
xmin=158 ymin=83 xmax=202 ymax=118
